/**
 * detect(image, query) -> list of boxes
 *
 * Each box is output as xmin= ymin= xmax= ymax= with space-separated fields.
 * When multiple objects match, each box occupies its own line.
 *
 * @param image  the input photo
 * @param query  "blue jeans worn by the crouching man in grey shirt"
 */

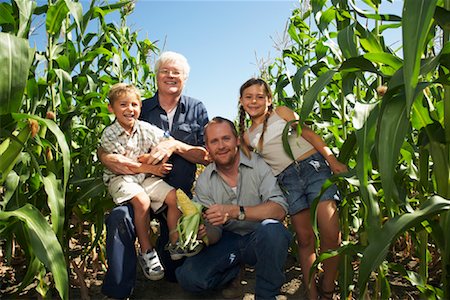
xmin=175 ymin=220 xmax=291 ymax=299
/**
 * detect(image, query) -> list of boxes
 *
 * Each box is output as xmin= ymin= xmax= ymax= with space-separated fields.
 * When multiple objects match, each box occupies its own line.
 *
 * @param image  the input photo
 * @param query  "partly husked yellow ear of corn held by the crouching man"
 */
xmin=176 ymin=189 xmax=209 ymax=250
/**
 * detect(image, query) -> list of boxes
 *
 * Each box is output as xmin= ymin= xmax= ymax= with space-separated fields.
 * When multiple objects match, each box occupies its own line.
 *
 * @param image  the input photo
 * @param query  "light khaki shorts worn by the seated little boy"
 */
xmin=108 ymin=175 xmax=173 ymax=212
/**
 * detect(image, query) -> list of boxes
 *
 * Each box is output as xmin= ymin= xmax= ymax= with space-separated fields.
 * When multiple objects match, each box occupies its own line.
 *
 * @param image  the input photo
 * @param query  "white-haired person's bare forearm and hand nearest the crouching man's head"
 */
xmin=139 ymin=139 xmax=209 ymax=165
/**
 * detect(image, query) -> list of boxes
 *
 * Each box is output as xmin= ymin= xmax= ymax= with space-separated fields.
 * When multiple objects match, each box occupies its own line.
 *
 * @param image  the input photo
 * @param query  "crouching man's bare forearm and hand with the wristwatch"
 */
xmin=205 ymin=201 xmax=286 ymax=225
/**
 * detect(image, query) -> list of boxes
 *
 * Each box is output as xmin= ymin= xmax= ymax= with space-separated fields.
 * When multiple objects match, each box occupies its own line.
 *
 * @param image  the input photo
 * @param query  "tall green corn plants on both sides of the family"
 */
xmin=0 ymin=0 xmax=450 ymax=299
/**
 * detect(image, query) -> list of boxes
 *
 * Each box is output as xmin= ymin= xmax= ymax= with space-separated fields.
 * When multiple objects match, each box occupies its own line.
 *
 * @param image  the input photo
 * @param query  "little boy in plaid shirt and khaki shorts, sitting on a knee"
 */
xmin=100 ymin=83 xmax=196 ymax=280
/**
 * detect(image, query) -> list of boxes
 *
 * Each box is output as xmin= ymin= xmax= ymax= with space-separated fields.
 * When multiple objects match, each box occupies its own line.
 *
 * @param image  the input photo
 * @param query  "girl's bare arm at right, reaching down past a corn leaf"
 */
xmin=276 ymin=106 xmax=347 ymax=174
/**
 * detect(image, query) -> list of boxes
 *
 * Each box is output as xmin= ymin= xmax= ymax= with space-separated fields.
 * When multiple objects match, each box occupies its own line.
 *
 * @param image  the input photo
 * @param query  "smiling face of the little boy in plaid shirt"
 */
xmin=108 ymin=92 xmax=141 ymax=133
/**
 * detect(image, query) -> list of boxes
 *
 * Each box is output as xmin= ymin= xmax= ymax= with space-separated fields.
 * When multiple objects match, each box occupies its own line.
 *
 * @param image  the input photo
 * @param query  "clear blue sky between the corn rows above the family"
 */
xmin=127 ymin=0 xmax=299 ymax=119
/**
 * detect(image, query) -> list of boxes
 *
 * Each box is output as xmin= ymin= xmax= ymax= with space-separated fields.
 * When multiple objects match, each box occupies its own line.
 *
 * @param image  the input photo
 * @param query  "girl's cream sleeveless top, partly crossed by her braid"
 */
xmin=247 ymin=112 xmax=314 ymax=176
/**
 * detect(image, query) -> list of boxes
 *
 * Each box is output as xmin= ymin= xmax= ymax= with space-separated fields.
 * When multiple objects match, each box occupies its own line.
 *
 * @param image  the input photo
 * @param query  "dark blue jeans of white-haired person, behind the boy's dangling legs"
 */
xmin=102 ymin=204 xmax=182 ymax=298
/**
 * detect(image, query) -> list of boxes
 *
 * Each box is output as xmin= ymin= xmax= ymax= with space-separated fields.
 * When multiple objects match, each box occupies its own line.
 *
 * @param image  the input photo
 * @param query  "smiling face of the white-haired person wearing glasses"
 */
xmin=156 ymin=61 xmax=187 ymax=95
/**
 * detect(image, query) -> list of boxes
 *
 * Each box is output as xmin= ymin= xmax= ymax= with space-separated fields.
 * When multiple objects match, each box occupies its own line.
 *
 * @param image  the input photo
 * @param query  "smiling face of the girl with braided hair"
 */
xmin=239 ymin=84 xmax=272 ymax=123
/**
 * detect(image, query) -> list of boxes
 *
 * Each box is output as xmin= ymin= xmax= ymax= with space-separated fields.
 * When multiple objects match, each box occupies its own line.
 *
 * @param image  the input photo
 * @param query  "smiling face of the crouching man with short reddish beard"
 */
xmin=205 ymin=122 xmax=239 ymax=168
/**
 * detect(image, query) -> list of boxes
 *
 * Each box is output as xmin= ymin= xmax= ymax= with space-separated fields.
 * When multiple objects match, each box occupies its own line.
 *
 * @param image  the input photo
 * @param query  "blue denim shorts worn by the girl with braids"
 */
xmin=277 ymin=152 xmax=340 ymax=215
